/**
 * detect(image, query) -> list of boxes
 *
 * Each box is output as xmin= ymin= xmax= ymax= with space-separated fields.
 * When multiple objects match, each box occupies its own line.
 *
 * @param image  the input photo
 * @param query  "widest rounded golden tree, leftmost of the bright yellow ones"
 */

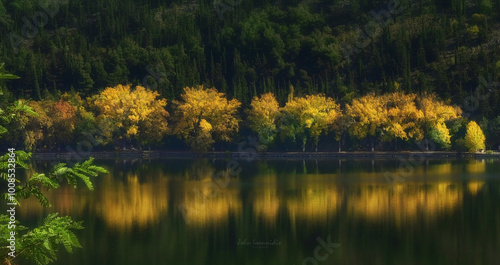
xmin=91 ymin=85 xmax=169 ymax=145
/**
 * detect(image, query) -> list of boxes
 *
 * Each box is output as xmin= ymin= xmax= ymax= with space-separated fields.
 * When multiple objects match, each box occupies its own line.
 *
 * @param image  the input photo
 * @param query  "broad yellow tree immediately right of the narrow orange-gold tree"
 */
xmin=279 ymin=95 xmax=342 ymax=151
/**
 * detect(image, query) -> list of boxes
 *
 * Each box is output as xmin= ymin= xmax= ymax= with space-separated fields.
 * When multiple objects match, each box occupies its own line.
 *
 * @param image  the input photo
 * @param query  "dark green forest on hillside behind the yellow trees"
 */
xmin=0 ymin=0 xmax=500 ymax=150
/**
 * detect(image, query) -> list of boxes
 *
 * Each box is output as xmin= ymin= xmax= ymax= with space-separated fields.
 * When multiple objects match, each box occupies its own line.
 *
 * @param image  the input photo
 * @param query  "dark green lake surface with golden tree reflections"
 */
xmin=18 ymin=160 xmax=500 ymax=265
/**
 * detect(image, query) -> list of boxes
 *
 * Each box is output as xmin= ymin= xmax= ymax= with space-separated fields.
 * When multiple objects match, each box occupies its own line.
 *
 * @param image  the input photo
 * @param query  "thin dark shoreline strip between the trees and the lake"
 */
xmin=32 ymin=151 xmax=500 ymax=160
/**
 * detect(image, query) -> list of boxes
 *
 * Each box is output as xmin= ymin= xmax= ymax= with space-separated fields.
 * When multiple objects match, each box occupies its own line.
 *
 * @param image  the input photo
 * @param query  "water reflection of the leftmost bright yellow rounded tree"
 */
xmin=96 ymin=174 xmax=168 ymax=229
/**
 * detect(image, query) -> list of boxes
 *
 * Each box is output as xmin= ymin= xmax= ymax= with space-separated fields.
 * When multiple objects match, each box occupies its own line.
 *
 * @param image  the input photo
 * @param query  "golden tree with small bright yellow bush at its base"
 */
xmin=174 ymin=85 xmax=241 ymax=151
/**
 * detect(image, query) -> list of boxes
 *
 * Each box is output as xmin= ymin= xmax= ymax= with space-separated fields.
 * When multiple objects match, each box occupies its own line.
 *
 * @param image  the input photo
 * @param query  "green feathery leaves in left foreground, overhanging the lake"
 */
xmin=0 ymin=67 xmax=107 ymax=265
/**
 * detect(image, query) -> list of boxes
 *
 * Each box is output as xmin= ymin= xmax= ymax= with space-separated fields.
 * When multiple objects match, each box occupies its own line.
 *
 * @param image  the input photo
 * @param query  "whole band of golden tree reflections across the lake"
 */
xmin=18 ymin=161 xmax=492 ymax=230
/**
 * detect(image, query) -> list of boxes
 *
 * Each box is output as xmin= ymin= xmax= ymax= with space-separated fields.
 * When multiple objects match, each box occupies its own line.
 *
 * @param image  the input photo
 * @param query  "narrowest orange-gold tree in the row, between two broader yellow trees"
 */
xmin=247 ymin=93 xmax=280 ymax=149
